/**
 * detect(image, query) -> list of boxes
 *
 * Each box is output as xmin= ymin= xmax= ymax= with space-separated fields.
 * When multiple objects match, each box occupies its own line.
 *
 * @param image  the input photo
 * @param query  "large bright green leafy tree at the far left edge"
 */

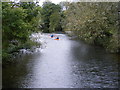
xmin=2 ymin=3 xmax=29 ymax=45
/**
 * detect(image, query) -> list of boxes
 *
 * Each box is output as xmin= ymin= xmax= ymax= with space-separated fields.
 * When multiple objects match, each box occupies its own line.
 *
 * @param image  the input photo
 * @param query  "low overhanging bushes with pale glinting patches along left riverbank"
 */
xmin=2 ymin=32 xmax=42 ymax=65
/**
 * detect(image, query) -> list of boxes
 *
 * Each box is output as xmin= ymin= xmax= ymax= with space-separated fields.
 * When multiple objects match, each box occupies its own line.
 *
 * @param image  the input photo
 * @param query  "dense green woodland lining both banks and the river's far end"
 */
xmin=2 ymin=1 xmax=120 ymax=60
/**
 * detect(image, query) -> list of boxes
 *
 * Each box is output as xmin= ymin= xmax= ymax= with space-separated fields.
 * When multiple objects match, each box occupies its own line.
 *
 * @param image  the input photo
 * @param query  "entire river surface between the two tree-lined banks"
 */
xmin=2 ymin=33 xmax=119 ymax=88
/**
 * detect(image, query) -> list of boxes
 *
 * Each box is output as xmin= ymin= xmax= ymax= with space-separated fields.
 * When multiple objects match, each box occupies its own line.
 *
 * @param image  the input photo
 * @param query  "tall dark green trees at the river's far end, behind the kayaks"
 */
xmin=41 ymin=2 xmax=61 ymax=32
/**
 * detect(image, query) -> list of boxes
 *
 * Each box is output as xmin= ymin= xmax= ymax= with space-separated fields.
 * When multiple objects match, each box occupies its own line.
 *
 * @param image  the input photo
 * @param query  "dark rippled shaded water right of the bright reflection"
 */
xmin=71 ymin=40 xmax=118 ymax=88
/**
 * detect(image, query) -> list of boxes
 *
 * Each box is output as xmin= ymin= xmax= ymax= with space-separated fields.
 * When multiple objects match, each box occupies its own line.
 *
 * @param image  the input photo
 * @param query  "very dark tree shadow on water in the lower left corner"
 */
xmin=2 ymin=54 xmax=31 ymax=88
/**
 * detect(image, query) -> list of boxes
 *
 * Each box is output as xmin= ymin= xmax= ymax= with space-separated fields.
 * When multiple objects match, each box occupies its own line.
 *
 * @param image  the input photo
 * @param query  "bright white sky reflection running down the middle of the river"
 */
xmin=22 ymin=34 xmax=72 ymax=88
